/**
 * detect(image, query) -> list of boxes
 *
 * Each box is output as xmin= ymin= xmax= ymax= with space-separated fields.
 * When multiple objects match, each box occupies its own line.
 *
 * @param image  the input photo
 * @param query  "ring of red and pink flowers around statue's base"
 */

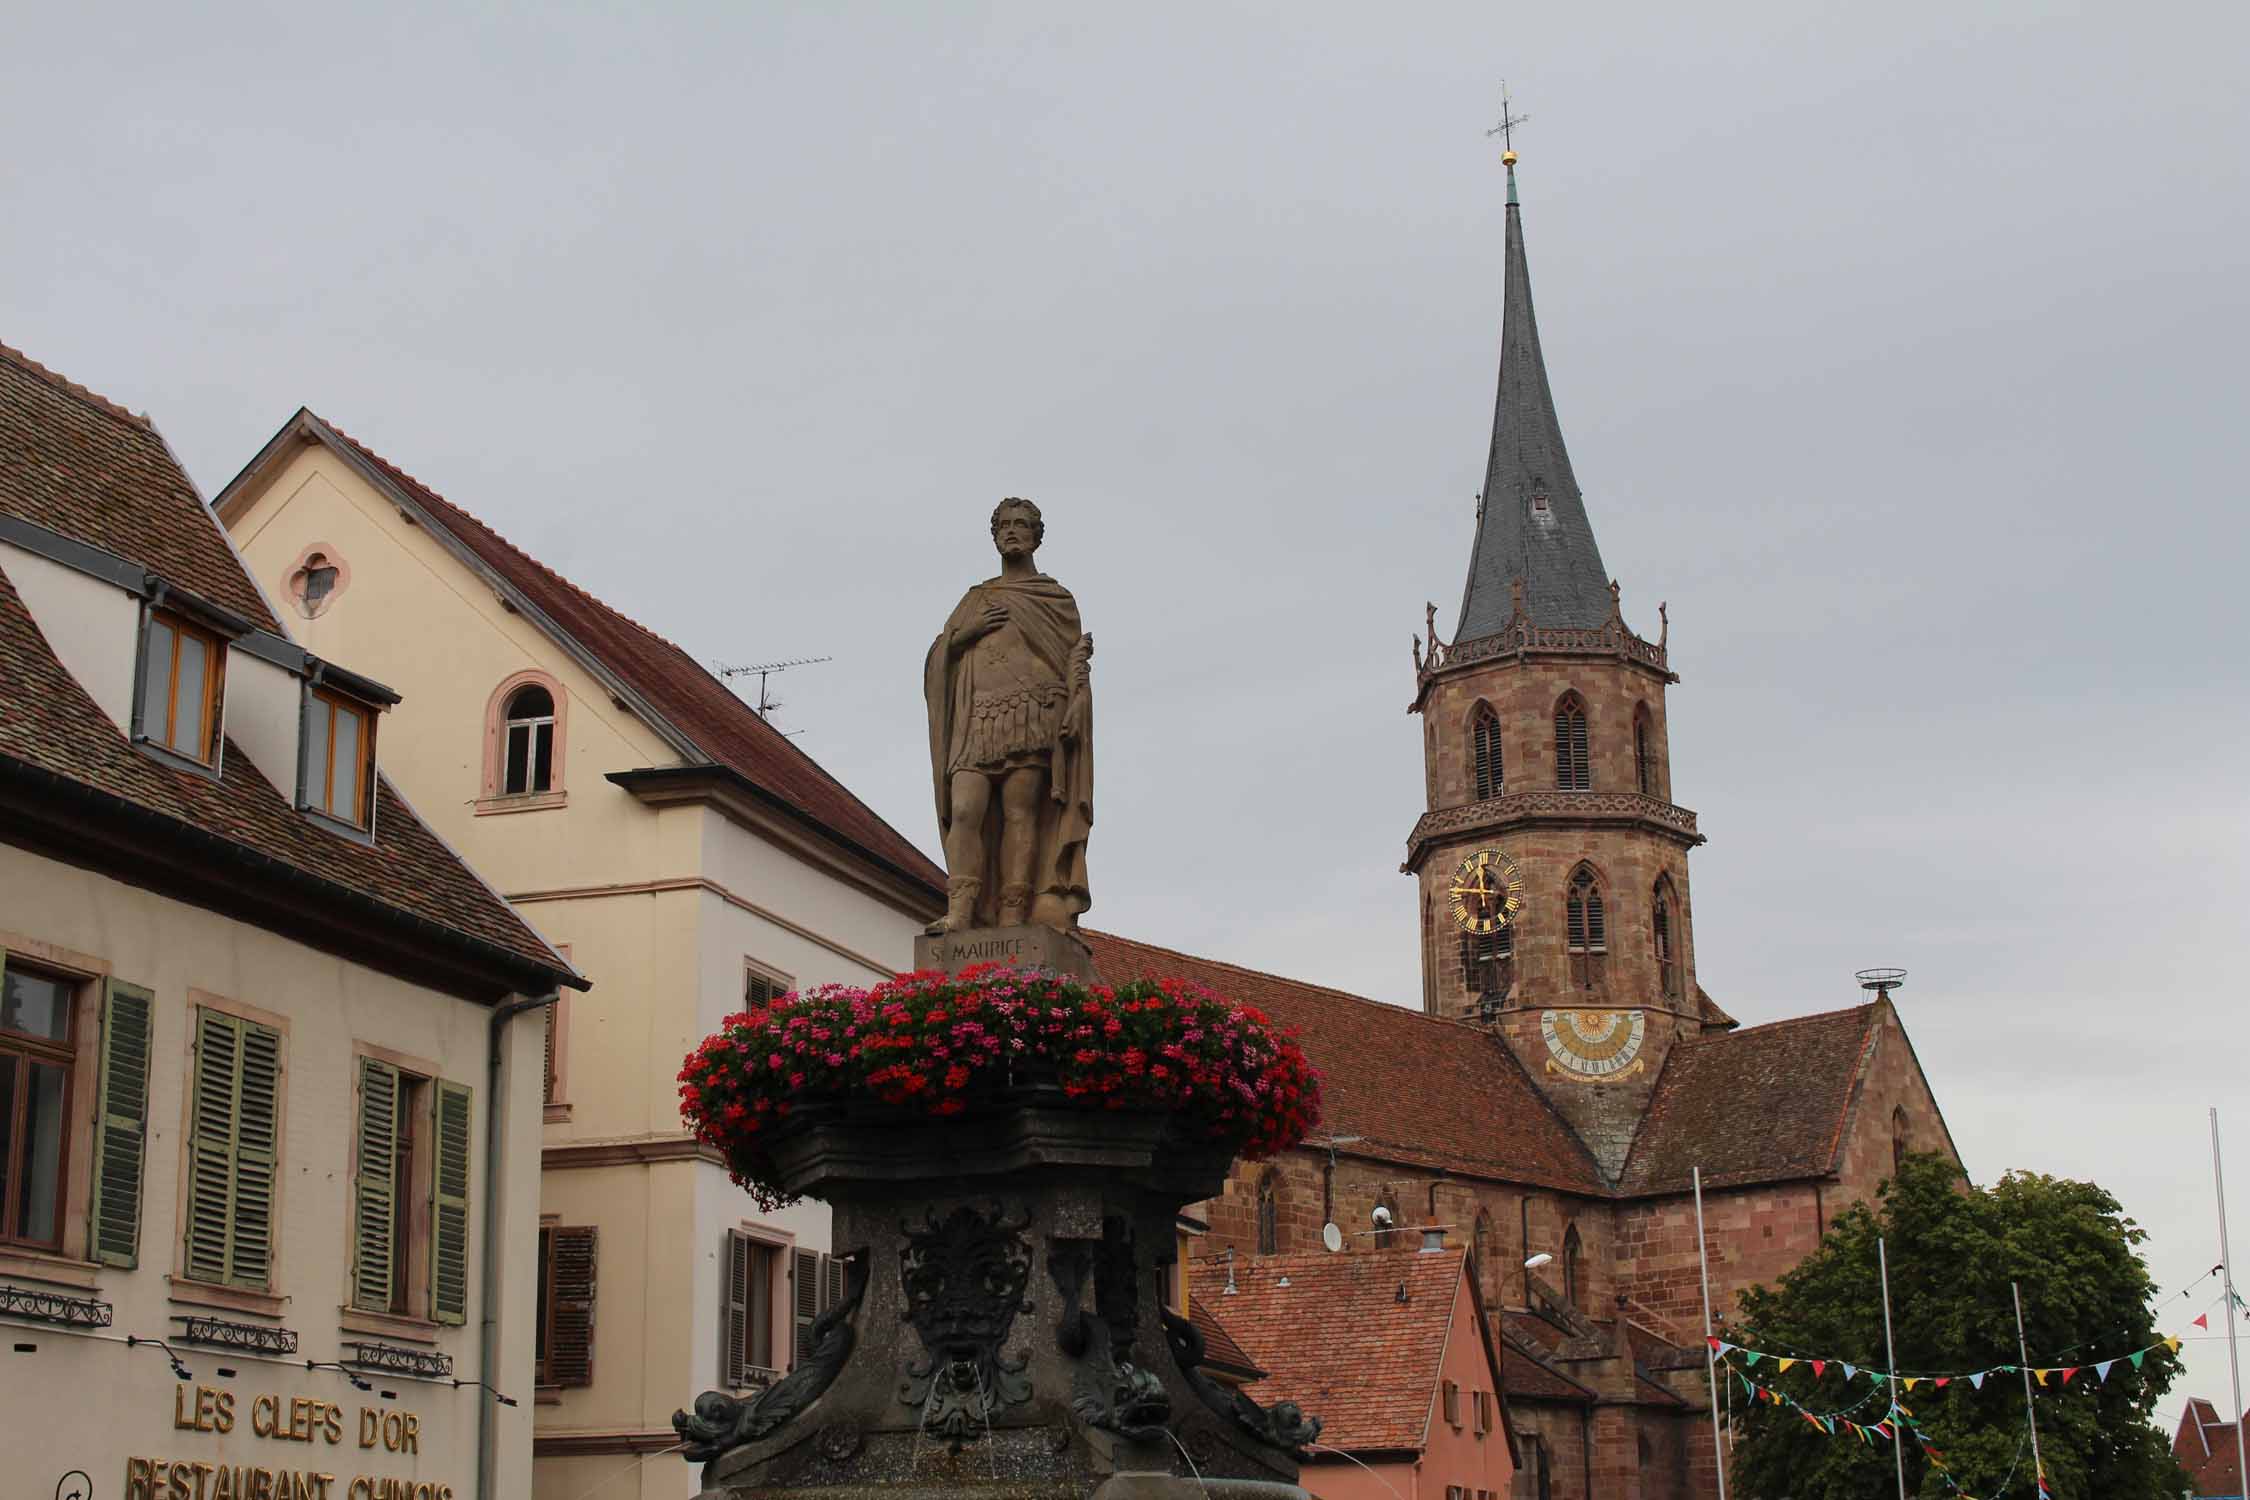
xmin=680 ymin=965 xmax=1321 ymax=1208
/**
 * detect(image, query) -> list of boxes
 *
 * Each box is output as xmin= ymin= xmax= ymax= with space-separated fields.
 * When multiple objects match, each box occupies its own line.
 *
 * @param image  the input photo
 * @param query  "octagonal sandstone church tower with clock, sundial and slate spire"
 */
xmin=1406 ymin=151 xmax=1708 ymax=1176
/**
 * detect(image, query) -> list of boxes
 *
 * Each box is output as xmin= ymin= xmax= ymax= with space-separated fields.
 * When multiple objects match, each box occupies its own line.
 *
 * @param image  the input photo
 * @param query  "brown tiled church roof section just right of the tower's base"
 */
xmin=1618 ymin=1005 xmax=1877 ymax=1196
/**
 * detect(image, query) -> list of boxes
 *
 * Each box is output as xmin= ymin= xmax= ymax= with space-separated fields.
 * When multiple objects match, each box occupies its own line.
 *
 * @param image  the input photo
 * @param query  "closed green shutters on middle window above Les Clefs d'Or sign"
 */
xmin=185 ymin=1007 xmax=281 ymax=1291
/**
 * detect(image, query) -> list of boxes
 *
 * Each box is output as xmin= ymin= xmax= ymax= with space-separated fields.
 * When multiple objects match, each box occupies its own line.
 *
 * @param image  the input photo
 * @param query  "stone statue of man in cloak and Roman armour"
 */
xmin=923 ymin=497 xmax=1094 ymax=933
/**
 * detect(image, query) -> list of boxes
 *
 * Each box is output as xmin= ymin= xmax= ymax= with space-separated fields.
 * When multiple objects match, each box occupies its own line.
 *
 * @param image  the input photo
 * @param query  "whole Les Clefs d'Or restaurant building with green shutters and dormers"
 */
xmin=0 ymin=346 xmax=583 ymax=1500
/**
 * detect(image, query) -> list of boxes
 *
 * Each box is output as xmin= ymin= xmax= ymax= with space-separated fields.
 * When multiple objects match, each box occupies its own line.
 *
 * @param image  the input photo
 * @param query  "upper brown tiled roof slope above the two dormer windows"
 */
xmin=0 ymin=344 xmax=277 ymax=630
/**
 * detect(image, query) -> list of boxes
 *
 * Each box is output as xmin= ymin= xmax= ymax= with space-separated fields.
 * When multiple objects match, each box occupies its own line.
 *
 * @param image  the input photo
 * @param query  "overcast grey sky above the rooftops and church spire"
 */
xmin=0 ymin=0 xmax=2250 ymax=1415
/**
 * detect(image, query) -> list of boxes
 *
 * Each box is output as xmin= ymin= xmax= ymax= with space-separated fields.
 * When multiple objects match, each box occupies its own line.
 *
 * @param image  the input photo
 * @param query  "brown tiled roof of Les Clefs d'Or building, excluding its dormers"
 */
xmin=0 ymin=351 xmax=569 ymax=976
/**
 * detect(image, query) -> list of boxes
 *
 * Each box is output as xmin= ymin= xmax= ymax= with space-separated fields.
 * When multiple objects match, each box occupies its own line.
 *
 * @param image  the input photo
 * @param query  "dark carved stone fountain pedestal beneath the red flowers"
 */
xmin=675 ymin=1101 xmax=1319 ymax=1500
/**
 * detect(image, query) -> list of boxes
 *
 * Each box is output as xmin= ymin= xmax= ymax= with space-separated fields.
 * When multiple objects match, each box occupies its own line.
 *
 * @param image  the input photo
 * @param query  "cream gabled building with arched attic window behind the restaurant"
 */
xmin=216 ymin=412 xmax=943 ymax=1500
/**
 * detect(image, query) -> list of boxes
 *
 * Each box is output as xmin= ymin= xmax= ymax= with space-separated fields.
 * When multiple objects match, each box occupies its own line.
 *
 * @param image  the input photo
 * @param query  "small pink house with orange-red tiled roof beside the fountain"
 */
xmin=1193 ymin=1250 xmax=1517 ymax=1500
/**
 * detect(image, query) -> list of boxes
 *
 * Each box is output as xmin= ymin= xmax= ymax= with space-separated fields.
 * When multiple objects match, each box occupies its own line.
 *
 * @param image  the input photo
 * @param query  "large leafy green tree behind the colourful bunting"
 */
xmin=1721 ymin=1156 xmax=2183 ymax=1500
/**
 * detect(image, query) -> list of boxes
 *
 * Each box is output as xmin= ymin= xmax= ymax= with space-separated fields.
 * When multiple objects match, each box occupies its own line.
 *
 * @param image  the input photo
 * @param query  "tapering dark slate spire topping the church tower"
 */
xmin=1454 ymin=151 xmax=1613 ymax=641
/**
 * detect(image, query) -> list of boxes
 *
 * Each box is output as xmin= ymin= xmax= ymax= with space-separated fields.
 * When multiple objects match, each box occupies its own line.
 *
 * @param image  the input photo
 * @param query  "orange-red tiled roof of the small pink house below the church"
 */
xmin=1193 ymin=1250 xmax=1478 ymax=1453
